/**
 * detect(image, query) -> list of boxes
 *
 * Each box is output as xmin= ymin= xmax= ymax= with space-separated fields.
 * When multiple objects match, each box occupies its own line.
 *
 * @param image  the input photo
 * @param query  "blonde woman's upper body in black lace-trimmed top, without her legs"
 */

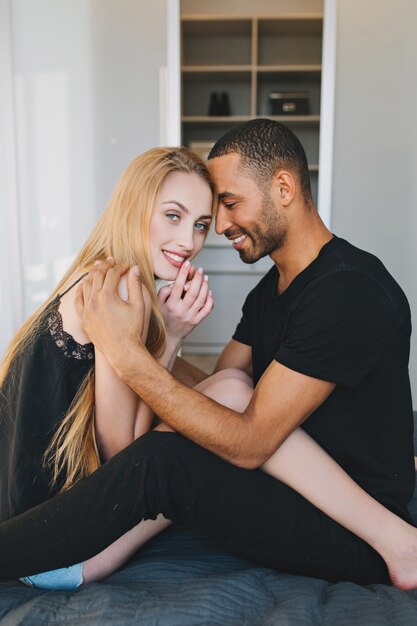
xmin=0 ymin=148 xmax=213 ymax=587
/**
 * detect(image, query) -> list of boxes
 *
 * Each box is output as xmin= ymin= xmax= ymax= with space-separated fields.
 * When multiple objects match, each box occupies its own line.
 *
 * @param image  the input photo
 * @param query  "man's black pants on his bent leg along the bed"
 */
xmin=0 ymin=432 xmax=388 ymax=584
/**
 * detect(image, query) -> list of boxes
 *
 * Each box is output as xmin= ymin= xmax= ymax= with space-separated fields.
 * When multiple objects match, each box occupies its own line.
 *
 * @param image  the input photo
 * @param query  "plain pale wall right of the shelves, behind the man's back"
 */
xmin=332 ymin=0 xmax=417 ymax=407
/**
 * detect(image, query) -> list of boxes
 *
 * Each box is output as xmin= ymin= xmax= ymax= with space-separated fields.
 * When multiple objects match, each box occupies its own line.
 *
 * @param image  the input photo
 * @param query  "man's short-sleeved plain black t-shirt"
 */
xmin=233 ymin=237 xmax=415 ymax=516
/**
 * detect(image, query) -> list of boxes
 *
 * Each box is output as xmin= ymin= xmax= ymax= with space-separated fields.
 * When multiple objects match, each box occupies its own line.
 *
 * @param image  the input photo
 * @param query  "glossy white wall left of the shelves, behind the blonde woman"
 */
xmin=0 ymin=0 xmax=167 ymax=352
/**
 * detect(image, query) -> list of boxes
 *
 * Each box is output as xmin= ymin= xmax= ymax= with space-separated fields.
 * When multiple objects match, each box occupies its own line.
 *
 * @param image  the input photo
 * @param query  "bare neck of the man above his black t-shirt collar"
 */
xmin=271 ymin=214 xmax=333 ymax=293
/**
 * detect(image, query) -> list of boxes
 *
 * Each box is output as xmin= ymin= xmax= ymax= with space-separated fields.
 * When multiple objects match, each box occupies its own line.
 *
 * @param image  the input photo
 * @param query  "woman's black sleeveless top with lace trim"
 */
xmin=0 ymin=277 xmax=94 ymax=520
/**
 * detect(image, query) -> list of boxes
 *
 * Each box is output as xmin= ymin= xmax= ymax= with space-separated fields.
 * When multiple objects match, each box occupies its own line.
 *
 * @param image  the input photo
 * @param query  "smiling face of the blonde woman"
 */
xmin=149 ymin=172 xmax=212 ymax=280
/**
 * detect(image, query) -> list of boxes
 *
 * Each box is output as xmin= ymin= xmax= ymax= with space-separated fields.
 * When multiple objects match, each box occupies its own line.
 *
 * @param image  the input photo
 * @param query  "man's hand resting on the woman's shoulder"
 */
xmin=76 ymin=259 xmax=146 ymax=369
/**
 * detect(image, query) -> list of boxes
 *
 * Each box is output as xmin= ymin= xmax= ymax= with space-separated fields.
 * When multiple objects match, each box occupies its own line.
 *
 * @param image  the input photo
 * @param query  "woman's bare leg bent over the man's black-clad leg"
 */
xmin=196 ymin=370 xmax=417 ymax=589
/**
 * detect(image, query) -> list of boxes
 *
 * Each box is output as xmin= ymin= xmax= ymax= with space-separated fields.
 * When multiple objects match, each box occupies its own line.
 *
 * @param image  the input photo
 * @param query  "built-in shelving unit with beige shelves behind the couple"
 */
xmin=181 ymin=13 xmax=323 ymax=354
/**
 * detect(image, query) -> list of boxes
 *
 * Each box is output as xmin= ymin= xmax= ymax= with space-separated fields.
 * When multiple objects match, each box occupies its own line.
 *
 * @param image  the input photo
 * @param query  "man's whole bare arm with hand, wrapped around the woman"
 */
xmin=77 ymin=260 xmax=334 ymax=468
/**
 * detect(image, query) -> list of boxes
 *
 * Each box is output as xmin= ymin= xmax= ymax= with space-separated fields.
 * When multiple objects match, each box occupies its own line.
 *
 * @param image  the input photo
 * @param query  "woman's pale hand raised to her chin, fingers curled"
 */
xmin=158 ymin=261 xmax=214 ymax=341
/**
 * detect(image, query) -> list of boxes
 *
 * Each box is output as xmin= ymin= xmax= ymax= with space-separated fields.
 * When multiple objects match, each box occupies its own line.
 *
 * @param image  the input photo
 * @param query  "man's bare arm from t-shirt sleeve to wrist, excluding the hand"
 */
xmin=118 ymin=344 xmax=334 ymax=468
